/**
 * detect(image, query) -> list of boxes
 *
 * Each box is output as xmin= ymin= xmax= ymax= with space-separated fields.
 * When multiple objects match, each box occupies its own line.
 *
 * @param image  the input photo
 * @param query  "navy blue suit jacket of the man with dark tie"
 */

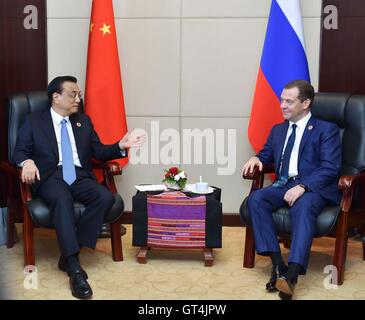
xmin=258 ymin=116 xmax=341 ymax=204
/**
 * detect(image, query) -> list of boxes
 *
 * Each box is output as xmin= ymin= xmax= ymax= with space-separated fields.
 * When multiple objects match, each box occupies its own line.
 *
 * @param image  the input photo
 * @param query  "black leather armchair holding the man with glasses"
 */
xmin=0 ymin=91 xmax=124 ymax=265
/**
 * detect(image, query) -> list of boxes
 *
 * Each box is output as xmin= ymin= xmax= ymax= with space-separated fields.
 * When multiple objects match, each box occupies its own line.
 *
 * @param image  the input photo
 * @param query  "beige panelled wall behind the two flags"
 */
xmin=47 ymin=0 xmax=321 ymax=213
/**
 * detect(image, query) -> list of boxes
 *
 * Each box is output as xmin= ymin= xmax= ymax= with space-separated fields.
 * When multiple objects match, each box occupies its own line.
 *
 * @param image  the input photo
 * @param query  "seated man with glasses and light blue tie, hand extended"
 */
xmin=14 ymin=76 xmax=145 ymax=299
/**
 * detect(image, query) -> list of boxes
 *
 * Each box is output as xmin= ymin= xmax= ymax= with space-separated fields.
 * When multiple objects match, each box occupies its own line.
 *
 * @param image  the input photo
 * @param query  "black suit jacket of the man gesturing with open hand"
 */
xmin=12 ymin=110 xmax=126 ymax=190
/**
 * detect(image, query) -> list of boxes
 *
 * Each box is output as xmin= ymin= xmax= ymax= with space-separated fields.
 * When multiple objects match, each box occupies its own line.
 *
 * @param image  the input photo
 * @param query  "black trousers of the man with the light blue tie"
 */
xmin=37 ymin=167 xmax=114 ymax=257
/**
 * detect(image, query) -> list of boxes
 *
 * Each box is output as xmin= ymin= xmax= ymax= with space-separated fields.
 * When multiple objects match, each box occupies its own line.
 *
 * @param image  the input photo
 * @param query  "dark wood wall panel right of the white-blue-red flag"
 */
xmin=319 ymin=0 xmax=365 ymax=94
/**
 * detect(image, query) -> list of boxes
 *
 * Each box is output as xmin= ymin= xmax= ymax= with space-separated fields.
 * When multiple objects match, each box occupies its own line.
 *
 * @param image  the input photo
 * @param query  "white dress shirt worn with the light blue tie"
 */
xmin=51 ymin=108 xmax=82 ymax=167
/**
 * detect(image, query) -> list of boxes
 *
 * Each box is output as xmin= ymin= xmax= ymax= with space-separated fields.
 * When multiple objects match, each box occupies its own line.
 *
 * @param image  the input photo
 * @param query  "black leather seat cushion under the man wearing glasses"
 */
xmin=26 ymin=193 xmax=124 ymax=229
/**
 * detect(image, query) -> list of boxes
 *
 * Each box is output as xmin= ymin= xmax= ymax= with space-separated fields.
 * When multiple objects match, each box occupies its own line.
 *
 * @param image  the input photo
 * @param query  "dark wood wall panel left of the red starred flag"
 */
xmin=0 ymin=0 xmax=47 ymax=207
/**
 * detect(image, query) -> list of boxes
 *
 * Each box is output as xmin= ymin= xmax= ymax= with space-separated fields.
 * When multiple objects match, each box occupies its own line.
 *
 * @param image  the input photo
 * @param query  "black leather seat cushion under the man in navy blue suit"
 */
xmin=240 ymin=198 xmax=341 ymax=237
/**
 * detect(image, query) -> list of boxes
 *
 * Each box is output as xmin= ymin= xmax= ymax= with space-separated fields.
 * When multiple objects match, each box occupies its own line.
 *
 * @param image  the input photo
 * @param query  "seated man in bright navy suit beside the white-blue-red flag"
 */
xmin=242 ymin=80 xmax=341 ymax=299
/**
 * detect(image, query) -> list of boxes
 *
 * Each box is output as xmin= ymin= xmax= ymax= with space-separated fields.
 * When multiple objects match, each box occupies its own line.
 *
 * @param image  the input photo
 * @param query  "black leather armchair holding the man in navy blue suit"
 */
xmin=240 ymin=93 xmax=365 ymax=285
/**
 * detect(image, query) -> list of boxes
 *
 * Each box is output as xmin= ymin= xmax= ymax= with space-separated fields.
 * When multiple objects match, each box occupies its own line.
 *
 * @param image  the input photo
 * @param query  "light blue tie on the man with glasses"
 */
xmin=61 ymin=119 xmax=76 ymax=185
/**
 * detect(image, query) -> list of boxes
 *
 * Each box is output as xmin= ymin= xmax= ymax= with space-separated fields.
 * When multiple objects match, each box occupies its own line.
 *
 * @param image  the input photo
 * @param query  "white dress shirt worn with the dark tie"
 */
xmin=282 ymin=112 xmax=311 ymax=177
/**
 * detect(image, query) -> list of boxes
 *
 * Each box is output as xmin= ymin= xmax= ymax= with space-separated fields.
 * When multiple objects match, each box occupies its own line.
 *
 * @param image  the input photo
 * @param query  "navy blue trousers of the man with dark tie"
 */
xmin=248 ymin=180 xmax=328 ymax=272
